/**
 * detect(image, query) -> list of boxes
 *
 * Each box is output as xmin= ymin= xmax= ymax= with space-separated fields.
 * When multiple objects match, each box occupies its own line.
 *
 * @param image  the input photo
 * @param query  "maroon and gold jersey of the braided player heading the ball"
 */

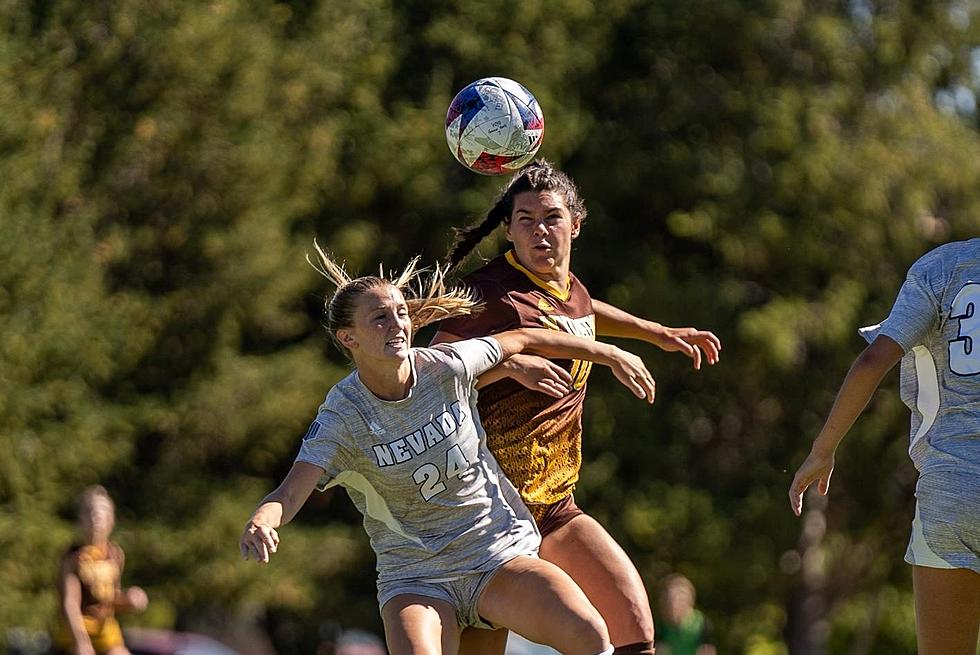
xmin=439 ymin=251 xmax=595 ymax=521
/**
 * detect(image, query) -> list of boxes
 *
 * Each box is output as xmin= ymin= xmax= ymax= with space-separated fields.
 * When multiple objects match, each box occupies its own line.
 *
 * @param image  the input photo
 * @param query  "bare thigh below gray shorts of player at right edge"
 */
xmin=912 ymin=566 xmax=980 ymax=655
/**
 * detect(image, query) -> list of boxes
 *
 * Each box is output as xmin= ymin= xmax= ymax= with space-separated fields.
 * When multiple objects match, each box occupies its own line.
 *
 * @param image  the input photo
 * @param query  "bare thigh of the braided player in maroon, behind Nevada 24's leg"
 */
xmin=540 ymin=514 xmax=653 ymax=646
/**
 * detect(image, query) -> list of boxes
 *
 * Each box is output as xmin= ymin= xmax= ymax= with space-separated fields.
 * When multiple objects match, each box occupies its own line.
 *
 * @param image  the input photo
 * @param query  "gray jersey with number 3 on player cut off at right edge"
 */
xmin=861 ymin=239 xmax=980 ymax=473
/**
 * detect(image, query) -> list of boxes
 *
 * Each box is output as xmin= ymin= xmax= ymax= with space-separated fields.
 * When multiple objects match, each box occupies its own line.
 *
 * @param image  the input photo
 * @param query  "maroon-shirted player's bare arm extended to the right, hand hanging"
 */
xmin=592 ymin=298 xmax=721 ymax=370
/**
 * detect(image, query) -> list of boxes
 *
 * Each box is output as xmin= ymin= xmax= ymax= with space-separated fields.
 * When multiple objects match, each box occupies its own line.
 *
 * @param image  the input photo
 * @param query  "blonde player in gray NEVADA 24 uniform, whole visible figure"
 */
xmin=240 ymin=248 xmax=653 ymax=655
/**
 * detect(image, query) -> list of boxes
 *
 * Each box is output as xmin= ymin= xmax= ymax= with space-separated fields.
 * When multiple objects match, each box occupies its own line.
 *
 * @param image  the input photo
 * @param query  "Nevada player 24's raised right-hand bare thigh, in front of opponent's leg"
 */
xmin=477 ymin=556 xmax=609 ymax=655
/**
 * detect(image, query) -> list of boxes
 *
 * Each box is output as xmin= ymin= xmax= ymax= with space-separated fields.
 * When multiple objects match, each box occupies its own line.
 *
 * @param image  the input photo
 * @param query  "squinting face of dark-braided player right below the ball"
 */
xmin=507 ymin=191 xmax=582 ymax=282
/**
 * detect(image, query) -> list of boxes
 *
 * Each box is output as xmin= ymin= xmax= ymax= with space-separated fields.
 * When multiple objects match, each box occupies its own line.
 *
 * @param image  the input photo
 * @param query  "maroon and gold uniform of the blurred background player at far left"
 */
xmin=55 ymin=542 xmax=124 ymax=653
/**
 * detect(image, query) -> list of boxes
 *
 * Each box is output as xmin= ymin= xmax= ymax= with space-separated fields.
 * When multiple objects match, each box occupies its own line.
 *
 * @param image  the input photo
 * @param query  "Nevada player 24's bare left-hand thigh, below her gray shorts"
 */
xmin=381 ymin=594 xmax=459 ymax=655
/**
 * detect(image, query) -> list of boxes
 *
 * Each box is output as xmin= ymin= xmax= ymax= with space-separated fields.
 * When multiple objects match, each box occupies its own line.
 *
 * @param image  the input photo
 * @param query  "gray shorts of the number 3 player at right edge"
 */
xmin=905 ymin=471 xmax=980 ymax=573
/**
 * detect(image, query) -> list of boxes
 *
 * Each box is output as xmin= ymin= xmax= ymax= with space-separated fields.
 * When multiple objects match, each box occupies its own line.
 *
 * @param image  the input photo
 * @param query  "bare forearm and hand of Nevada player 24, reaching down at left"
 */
xmin=238 ymin=462 xmax=323 ymax=562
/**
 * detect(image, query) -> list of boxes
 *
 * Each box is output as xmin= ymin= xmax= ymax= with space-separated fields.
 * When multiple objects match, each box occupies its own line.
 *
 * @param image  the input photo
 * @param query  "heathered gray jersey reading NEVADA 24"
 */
xmin=296 ymin=337 xmax=540 ymax=582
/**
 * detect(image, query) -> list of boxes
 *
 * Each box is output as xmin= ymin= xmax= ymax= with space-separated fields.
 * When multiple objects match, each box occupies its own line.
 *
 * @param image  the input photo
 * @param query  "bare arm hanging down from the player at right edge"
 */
xmin=789 ymin=335 xmax=904 ymax=516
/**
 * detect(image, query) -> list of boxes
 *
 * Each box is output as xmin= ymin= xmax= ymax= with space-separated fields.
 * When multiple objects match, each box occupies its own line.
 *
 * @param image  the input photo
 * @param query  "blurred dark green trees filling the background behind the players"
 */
xmin=0 ymin=0 xmax=980 ymax=655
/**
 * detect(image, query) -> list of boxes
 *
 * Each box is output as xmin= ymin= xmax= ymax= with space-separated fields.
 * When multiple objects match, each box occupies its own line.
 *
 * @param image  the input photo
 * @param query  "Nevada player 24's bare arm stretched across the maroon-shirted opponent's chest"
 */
xmin=493 ymin=328 xmax=656 ymax=403
